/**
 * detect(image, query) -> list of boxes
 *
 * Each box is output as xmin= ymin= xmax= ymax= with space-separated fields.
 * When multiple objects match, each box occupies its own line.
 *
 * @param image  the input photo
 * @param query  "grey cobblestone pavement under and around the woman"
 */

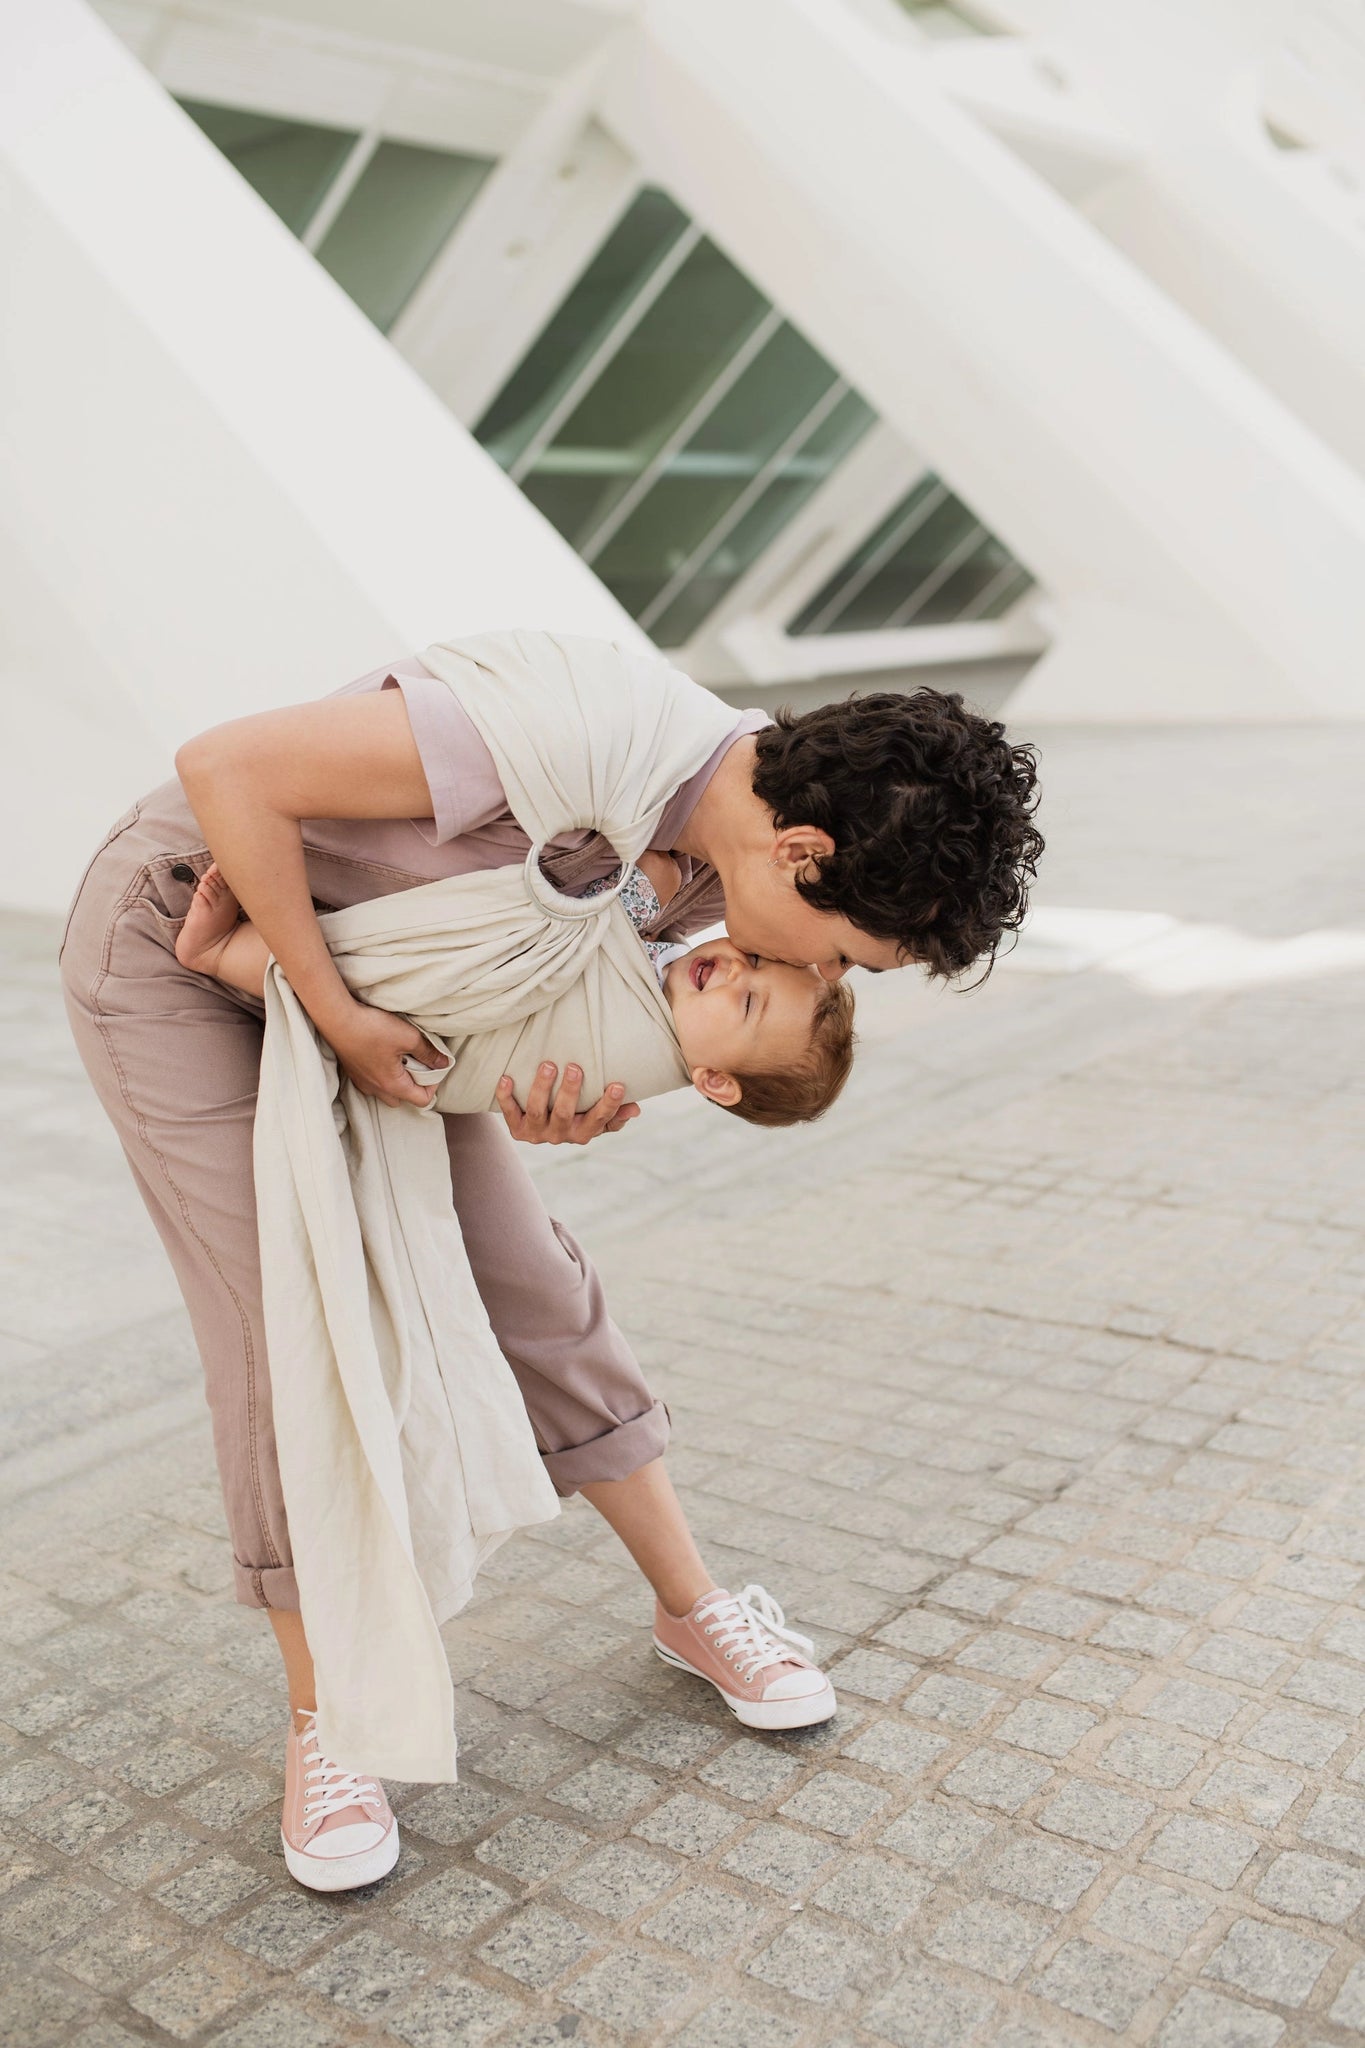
xmin=0 ymin=731 xmax=1365 ymax=2048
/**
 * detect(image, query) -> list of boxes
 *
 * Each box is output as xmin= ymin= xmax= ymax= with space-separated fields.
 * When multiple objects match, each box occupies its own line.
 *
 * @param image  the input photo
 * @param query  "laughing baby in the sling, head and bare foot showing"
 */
xmin=176 ymin=852 xmax=853 ymax=1124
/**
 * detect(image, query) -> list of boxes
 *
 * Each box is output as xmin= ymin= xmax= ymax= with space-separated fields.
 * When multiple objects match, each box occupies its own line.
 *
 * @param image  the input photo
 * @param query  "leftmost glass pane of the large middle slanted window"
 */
xmin=475 ymin=186 xmax=688 ymax=469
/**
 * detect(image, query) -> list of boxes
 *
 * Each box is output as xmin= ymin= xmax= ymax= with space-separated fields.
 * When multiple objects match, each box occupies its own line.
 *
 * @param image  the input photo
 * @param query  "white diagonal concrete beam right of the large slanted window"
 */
xmin=602 ymin=0 xmax=1365 ymax=717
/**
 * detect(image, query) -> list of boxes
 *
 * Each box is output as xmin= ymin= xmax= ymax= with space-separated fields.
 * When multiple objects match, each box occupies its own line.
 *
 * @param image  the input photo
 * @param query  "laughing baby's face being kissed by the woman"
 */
xmin=663 ymin=938 xmax=825 ymax=1075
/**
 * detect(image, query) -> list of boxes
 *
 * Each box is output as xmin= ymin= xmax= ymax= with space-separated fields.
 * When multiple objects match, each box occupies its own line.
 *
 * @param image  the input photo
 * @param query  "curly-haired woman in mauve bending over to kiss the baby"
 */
xmin=61 ymin=635 xmax=1040 ymax=1890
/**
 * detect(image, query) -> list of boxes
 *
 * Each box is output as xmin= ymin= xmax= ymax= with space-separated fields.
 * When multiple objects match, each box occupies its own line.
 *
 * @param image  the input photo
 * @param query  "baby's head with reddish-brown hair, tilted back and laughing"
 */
xmin=663 ymin=938 xmax=853 ymax=1124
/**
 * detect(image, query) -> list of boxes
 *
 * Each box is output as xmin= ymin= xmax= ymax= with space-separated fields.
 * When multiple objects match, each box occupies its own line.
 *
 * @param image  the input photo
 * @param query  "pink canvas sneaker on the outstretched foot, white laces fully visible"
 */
xmin=655 ymin=1585 xmax=839 ymax=1729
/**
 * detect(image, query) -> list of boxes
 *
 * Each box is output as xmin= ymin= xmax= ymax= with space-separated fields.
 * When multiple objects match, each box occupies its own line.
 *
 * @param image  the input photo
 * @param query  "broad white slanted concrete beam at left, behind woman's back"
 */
xmin=0 ymin=0 xmax=647 ymax=907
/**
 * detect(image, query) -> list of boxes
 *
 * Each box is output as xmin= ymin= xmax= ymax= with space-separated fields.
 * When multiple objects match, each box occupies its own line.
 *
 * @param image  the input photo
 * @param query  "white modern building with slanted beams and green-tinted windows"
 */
xmin=0 ymin=0 xmax=1365 ymax=907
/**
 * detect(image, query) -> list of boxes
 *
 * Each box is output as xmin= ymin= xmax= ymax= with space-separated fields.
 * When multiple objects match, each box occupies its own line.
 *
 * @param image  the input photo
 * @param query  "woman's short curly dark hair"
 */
xmin=753 ymin=690 xmax=1044 ymax=981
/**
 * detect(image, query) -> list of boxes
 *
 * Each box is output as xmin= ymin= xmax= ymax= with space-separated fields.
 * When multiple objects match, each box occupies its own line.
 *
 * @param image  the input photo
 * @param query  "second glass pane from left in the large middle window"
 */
xmin=527 ymin=242 xmax=767 ymax=545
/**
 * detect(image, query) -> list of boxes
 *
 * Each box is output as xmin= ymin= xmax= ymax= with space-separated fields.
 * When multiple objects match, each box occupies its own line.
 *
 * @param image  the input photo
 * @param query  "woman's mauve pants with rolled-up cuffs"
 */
xmin=61 ymin=782 xmax=667 ymax=1608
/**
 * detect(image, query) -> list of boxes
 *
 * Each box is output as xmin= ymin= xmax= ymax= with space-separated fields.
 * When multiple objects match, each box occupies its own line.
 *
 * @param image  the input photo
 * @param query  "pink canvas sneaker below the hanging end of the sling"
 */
xmin=280 ymin=1708 xmax=399 ymax=1892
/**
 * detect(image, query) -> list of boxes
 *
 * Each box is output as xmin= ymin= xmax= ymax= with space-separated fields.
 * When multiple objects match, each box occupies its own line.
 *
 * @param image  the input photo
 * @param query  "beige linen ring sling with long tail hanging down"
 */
xmin=256 ymin=633 xmax=735 ymax=1782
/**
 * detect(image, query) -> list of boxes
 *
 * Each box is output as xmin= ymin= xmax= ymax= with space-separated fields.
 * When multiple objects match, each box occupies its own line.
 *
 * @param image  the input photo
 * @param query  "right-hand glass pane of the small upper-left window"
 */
xmin=317 ymin=141 xmax=491 ymax=334
